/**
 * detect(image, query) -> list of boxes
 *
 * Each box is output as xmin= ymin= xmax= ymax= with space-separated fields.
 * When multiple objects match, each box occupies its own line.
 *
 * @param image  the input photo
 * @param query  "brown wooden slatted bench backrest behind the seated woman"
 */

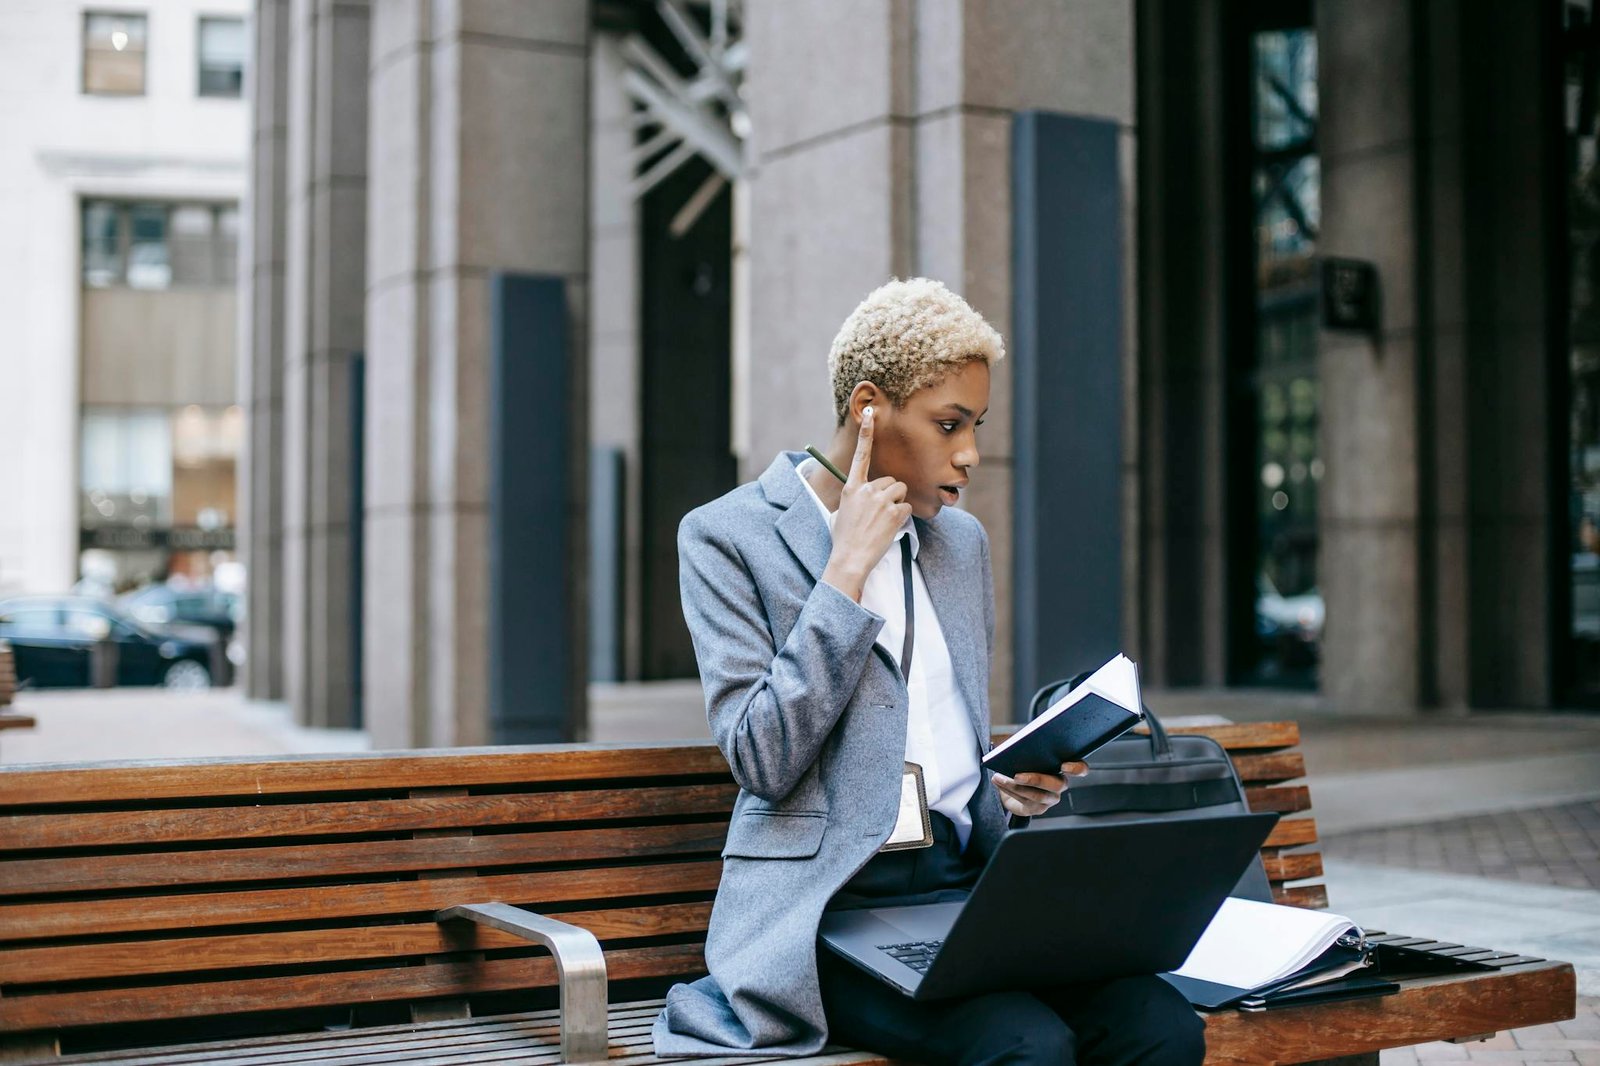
xmin=0 ymin=723 xmax=1325 ymax=1034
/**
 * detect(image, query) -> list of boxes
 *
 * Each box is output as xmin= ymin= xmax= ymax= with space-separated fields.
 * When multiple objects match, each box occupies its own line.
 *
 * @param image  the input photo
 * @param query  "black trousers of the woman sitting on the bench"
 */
xmin=818 ymin=813 xmax=1205 ymax=1066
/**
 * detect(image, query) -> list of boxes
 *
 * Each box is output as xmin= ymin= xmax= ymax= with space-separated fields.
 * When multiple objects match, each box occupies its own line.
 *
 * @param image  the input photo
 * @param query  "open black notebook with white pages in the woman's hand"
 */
xmin=984 ymin=655 xmax=1144 ymax=776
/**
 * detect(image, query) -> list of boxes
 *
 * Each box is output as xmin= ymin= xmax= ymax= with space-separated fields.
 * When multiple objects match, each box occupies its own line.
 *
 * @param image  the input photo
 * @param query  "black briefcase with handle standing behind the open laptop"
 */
xmin=1027 ymin=672 xmax=1272 ymax=903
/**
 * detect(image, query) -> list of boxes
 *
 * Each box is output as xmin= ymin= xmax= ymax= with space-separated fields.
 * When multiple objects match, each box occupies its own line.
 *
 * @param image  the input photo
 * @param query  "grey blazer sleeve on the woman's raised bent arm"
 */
xmin=678 ymin=512 xmax=883 ymax=802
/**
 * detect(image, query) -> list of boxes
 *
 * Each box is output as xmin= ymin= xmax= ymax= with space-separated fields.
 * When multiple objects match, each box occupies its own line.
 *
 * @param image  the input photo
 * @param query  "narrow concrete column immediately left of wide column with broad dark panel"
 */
xmin=283 ymin=0 xmax=370 ymax=727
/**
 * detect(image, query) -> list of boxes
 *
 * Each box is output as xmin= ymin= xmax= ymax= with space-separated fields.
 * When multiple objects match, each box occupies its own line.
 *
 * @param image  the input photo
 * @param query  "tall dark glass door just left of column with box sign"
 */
xmin=1230 ymin=3 xmax=1323 ymax=688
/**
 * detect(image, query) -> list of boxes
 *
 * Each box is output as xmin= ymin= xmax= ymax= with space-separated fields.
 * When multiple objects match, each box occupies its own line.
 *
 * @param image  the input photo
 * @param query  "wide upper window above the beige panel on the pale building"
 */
xmin=83 ymin=200 xmax=238 ymax=290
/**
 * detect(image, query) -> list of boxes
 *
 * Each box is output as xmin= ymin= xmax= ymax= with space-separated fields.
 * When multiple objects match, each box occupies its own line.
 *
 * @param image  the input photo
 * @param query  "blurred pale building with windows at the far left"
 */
xmin=0 ymin=0 xmax=250 ymax=597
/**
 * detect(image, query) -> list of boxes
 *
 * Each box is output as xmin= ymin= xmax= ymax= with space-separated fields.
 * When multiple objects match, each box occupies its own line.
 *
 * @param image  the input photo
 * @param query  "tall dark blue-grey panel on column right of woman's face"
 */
xmin=995 ymin=112 xmax=1123 ymax=720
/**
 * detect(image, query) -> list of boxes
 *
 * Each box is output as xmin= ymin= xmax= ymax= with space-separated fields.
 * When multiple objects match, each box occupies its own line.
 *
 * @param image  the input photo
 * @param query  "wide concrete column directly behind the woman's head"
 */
xmin=741 ymin=0 xmax=1138 ymax=720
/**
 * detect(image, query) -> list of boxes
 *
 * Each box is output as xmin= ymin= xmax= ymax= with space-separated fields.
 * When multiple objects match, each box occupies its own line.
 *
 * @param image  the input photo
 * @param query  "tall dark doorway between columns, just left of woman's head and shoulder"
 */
xmin=636 ymin=158 xmax=738 ymax=680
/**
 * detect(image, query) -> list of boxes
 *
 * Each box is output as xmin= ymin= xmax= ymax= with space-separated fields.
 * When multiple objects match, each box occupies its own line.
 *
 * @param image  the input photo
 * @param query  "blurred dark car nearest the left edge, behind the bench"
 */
xmin=0 ymin=595 xmax=214 ymax=688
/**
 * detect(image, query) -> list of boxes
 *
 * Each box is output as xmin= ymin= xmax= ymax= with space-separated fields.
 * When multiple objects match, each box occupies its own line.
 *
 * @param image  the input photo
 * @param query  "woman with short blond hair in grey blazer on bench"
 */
xmin=654 ymin=279 xmax=1203 ymax=1064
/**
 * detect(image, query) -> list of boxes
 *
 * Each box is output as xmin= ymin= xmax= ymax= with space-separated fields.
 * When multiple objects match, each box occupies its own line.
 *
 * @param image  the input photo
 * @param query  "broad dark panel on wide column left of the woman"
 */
xmin=488 ymin=274 xmax=584 ymax=744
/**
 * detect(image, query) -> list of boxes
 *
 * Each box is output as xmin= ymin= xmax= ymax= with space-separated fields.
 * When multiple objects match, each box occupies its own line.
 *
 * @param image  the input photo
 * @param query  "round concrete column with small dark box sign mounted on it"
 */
xmin=1315 ymin=0 xmax=1422 ymax=712
